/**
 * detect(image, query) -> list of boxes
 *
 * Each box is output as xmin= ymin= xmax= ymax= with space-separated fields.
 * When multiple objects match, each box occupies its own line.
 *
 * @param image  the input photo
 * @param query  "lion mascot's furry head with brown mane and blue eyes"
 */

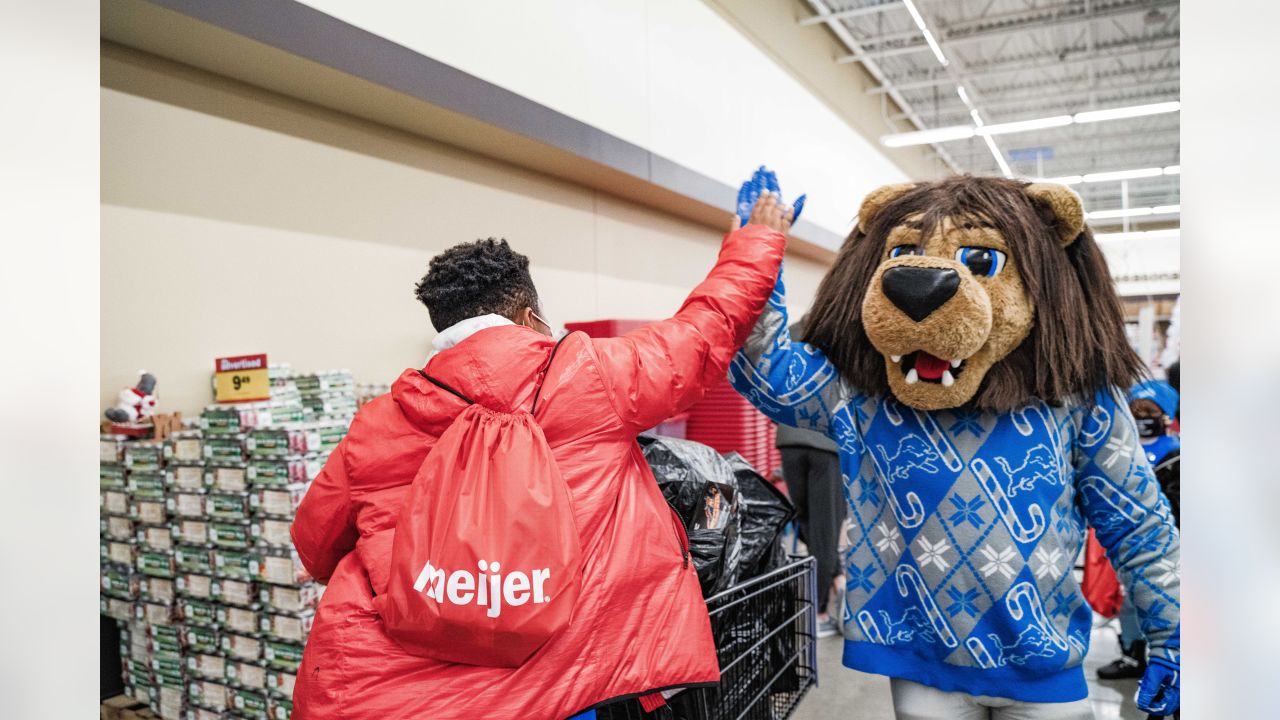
xmin=804 ymin=176 xmax=1143 ymax=411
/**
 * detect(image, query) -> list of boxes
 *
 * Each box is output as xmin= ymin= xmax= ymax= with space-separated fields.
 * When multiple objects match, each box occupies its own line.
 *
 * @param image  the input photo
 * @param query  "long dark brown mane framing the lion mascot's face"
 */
xmin=804 ymin=176 xmax=1143 ymax=413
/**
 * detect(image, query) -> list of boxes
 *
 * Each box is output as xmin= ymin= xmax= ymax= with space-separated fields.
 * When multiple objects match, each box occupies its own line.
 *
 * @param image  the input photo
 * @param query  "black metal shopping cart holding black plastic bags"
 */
xmin=596 ymin=557 xmax=818 ymax=720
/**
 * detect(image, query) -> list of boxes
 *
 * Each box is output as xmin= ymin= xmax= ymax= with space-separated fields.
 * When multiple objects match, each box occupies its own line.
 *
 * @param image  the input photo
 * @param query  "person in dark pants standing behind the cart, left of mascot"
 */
xmin=776 ymin=319 xmax=849 ymax=638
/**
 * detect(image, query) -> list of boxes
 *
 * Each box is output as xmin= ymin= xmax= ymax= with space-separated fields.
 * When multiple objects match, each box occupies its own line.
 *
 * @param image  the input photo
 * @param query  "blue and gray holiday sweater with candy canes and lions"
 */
xmin=730 ymin=270 xmax=1179 ymax=702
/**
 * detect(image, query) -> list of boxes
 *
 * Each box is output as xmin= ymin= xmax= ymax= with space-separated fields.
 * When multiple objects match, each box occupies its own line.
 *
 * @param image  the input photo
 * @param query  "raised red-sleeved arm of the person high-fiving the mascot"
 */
xmin=593 ymin=195 xmax=791 ymax=432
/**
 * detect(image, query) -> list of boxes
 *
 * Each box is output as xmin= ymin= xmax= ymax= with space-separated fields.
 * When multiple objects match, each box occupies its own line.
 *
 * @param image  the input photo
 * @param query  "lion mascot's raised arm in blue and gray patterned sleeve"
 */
xmin=728 ymin=269 xmax=850 ymax=436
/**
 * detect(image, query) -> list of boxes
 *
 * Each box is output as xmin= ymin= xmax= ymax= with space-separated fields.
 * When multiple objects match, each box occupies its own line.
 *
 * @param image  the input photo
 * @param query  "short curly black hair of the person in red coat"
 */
xmin=413 ymin=237 xmax=539 ymax=332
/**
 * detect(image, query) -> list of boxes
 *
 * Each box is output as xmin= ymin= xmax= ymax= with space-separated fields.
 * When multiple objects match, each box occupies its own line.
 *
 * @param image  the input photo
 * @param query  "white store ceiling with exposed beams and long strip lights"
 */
xmin=799 ymin=0 xmax=1179 ymax=222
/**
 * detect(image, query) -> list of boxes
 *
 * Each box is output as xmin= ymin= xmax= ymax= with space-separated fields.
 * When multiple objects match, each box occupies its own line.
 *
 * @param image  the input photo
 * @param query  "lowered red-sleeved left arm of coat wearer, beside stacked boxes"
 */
xmin=289 ymin=441 xmax=358 ymax=583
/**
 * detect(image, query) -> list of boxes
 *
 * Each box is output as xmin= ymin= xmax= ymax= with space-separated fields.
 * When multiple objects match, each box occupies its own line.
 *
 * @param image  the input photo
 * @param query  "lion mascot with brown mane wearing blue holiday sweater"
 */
xmin=730 ymin=176 xmax=1180 ymax=720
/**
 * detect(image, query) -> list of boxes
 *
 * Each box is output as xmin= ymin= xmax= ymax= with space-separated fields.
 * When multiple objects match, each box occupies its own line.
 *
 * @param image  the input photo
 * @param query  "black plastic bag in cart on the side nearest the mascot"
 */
xmin=724 ymin=452 xmax=796 ymax=580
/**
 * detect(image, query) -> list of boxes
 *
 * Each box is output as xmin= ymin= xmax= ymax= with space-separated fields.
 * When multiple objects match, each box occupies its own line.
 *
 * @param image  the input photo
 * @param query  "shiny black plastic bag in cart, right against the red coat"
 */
xmin=640 ymin=436 xmax=741 ymax=596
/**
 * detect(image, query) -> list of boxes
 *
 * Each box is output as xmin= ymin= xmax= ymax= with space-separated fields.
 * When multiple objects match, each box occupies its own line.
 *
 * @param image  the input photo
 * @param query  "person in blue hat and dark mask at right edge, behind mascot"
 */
xmin=1098 ymin=381 xmax=1181 ymax=680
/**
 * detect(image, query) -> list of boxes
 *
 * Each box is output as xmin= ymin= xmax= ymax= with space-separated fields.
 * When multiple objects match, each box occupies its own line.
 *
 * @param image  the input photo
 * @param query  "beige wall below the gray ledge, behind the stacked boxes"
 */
xmin=101 ymin=55 xmax=824 ymax=414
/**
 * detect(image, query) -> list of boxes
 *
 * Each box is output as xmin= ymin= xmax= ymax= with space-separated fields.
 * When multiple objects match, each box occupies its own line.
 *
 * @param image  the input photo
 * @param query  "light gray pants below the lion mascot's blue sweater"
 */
xmin=890 ymin=678 xmax=1093 ymax=720
